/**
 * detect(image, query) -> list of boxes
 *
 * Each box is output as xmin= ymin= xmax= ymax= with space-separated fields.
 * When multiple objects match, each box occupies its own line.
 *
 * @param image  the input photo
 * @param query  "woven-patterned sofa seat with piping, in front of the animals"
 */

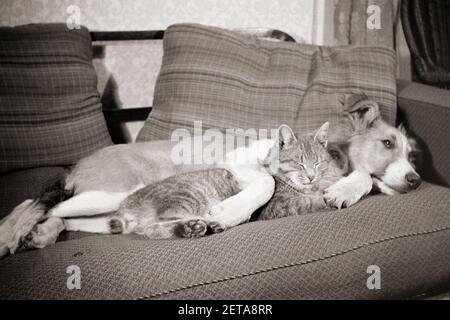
xmin=0 ymin=183 xmax=450 ymax=299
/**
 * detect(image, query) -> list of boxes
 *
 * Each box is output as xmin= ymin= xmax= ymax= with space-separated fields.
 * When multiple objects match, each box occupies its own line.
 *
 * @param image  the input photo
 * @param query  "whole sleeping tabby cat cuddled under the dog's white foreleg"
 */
xmin=89 ymin=123 xmax=342 ymax=239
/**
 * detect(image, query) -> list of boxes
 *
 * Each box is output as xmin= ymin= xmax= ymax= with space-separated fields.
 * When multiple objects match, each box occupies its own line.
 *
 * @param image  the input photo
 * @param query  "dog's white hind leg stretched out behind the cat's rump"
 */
xmin=48 ymin=187 xmax=140 ymax=218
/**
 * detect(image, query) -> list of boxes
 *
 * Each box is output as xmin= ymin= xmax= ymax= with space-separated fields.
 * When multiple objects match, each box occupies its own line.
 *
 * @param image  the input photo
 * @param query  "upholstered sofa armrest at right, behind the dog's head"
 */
xmin=397 ymin=80 xmax=450 ymax=187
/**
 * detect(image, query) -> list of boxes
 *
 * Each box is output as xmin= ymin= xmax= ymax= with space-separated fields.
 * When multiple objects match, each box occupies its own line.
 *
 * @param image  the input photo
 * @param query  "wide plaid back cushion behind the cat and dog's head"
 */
xmin=138 ymin=24 xmax=396 ymax=141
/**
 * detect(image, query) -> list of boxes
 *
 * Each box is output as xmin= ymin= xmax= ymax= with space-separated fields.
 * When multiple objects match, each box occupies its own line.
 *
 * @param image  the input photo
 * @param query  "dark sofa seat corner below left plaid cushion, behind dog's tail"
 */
xmin=0 ymin=167 xmax=66 ymax=219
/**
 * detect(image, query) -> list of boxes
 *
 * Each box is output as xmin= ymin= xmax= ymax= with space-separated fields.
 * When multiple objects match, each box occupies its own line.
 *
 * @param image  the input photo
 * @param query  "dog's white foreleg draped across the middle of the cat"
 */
xmin=211 ymin=175 xmax=275 ymax=228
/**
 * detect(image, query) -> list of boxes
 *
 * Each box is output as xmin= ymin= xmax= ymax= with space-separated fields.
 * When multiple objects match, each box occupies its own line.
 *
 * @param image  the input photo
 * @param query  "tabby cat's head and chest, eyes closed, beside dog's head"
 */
xmin=256 ymin=122 xmax=348 ymax=220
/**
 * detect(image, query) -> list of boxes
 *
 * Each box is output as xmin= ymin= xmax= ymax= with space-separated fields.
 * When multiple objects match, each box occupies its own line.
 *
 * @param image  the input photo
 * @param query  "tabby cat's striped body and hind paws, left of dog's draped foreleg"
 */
xmin=109 ymin=168 xmax=240 ymax=239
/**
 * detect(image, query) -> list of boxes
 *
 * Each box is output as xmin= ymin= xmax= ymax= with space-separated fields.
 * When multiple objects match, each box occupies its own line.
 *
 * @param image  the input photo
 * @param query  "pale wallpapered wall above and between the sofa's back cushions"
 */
xmin=0 ymin=0 xmax=327 ymax=139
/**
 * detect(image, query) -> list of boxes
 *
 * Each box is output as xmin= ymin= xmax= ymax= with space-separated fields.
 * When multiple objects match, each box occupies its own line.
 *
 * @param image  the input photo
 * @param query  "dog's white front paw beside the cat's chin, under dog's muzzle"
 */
xmin=324 ymin=170 xmax=372 ymax=209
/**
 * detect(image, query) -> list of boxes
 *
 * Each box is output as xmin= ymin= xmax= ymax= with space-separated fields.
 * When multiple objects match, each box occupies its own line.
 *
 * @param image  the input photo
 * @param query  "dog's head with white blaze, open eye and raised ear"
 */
xmin=347 ymin=97 xmax=421 ymax=193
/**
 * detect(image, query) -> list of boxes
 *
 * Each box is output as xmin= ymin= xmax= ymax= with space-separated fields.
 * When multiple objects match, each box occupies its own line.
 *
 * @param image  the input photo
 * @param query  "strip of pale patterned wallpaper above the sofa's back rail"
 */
xmin=0 ymin=0 xmax=321 ymax=42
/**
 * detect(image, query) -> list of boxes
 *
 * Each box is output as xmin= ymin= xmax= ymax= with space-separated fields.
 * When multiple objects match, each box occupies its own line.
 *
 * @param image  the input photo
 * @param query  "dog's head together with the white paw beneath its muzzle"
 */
xmin=324 ymin=94 xmax=421 ymax=208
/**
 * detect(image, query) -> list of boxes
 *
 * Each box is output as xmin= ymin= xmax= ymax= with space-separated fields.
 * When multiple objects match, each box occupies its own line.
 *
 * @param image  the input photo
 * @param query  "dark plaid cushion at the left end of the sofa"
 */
xmin=0 ymin=24 xmax=111 ymax=171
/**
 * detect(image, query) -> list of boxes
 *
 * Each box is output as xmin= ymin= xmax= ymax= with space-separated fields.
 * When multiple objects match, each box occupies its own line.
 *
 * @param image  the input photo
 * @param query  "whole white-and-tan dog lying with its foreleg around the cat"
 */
xmin=0 ymin=94 xmax=421 ymax=257
